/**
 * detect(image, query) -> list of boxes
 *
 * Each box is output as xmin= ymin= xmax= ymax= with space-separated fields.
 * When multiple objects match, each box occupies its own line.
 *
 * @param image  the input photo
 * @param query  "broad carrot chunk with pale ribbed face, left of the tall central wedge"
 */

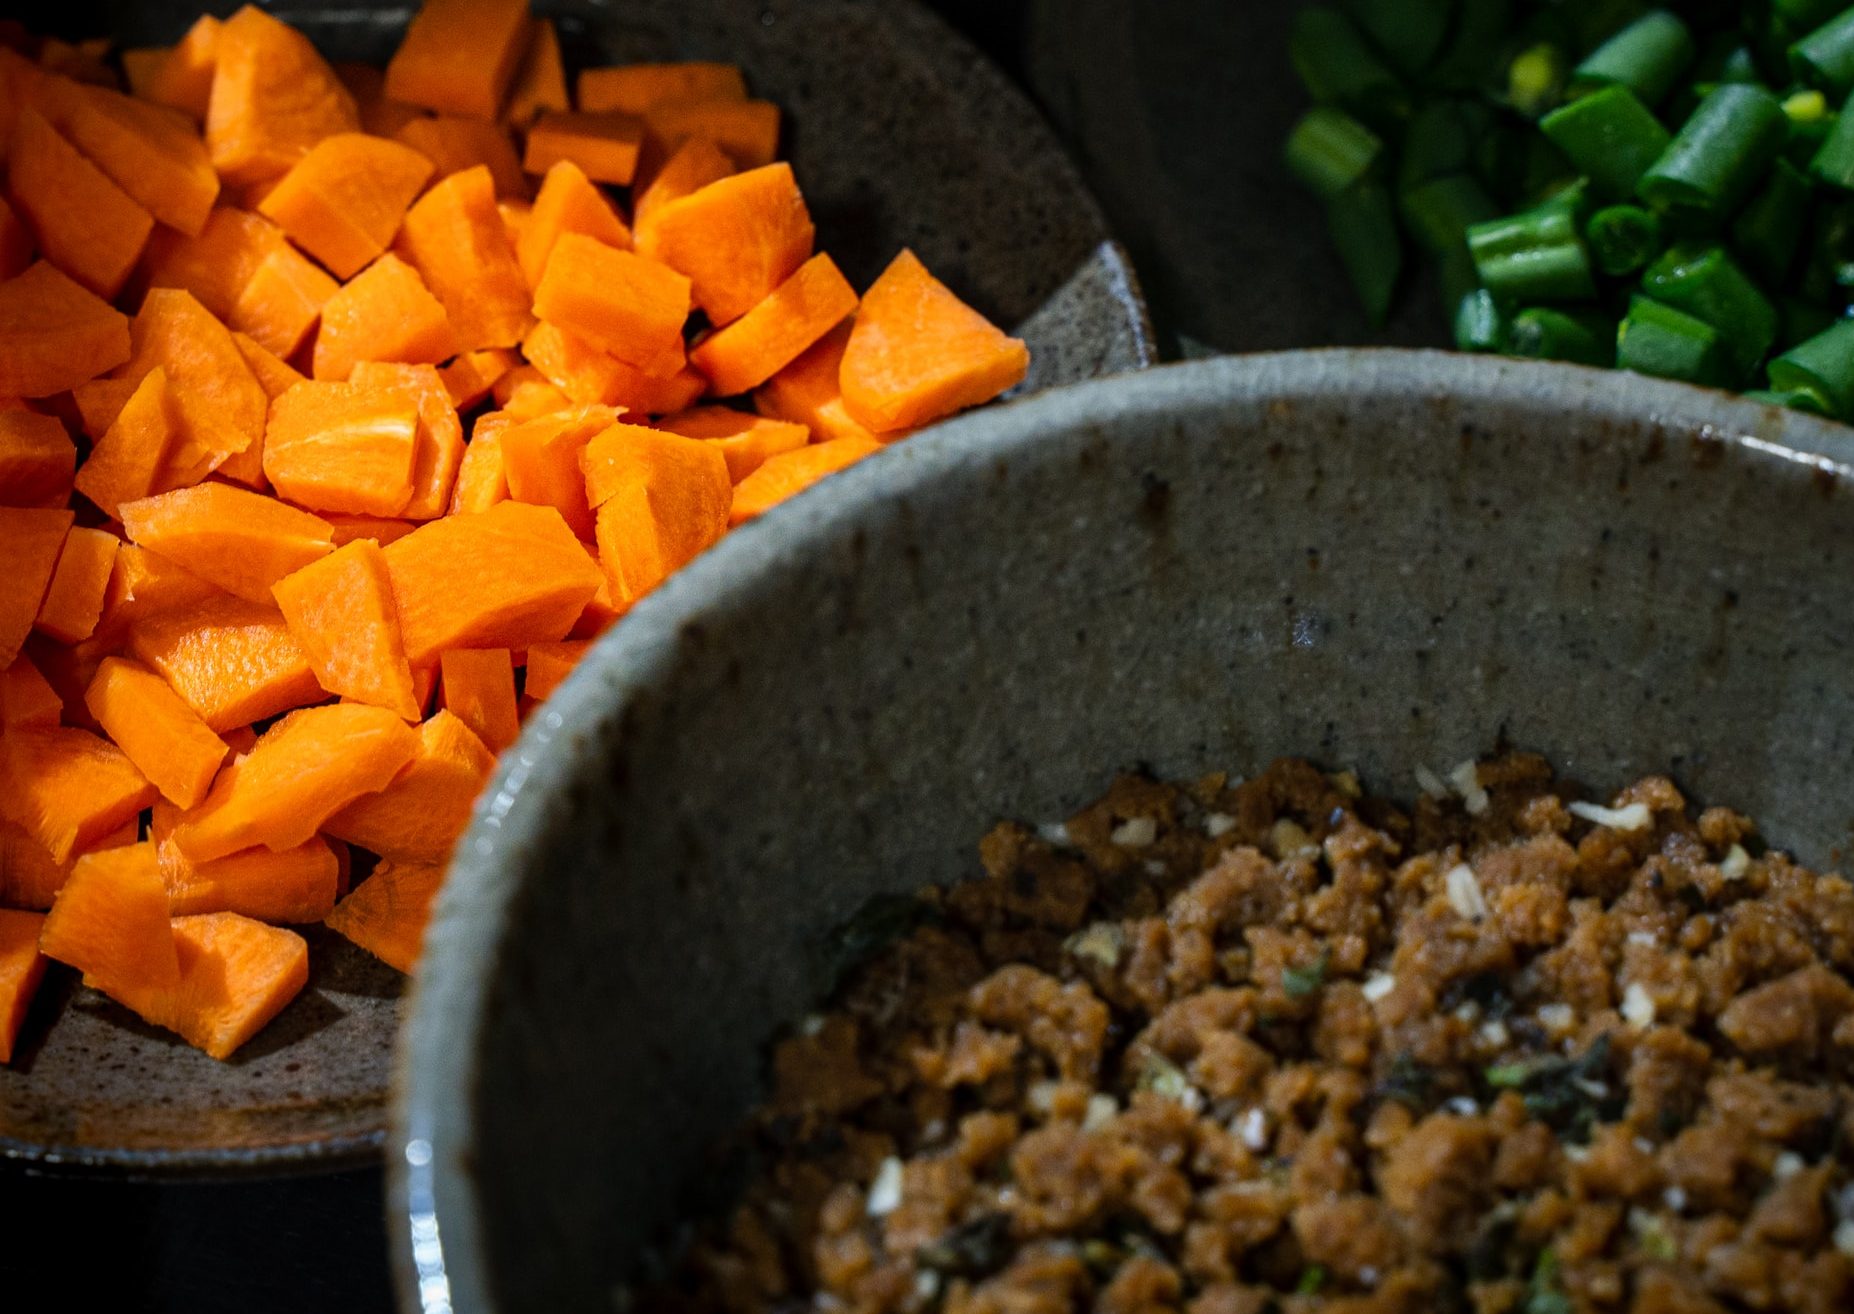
xmin=126 ymin=593 xmax=328 ymax=734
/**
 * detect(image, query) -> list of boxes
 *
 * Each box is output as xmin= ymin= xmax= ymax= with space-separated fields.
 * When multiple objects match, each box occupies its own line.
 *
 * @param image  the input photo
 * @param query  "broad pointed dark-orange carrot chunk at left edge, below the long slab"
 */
xmin=0 ymin=259 xmax=130 ymax=397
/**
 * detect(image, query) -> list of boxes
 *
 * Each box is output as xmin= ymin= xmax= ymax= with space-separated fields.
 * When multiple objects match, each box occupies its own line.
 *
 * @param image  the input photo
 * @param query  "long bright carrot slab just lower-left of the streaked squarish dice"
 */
xmin=122 ymin=481 xmax=334 ymax=606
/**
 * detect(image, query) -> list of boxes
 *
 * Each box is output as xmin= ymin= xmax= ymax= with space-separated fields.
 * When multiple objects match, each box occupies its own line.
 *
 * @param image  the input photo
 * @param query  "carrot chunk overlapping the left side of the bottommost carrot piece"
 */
xmin=39 ymin=843 xmax=180 ymax=995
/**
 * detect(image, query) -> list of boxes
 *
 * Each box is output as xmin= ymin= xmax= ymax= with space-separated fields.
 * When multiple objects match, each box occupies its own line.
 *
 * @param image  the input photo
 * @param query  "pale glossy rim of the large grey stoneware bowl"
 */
xmin=386 ymin=348 xmax=1854 ymax=1314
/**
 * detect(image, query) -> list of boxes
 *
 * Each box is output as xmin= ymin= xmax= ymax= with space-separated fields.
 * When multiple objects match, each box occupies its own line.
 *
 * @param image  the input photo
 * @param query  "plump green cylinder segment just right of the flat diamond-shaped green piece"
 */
xmin=1637 ymin=83 xmax=1789 ymax=224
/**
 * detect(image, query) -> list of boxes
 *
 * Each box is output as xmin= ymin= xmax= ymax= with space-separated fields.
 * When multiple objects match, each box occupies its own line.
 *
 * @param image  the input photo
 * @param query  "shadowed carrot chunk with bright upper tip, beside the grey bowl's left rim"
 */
xmin=323 ymin=707 xmax=489 ymax=862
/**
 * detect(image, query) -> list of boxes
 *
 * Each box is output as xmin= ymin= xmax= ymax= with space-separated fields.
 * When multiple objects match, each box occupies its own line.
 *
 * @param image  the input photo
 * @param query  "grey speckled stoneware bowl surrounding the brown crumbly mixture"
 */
xmin=398 ymin=352 xmax=1854 ymax=1314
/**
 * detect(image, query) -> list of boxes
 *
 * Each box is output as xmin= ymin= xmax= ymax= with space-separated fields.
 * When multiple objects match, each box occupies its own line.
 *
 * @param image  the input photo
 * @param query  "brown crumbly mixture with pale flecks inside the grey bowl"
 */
xmin=640 ymin=754 xmax=1854 ymax=1314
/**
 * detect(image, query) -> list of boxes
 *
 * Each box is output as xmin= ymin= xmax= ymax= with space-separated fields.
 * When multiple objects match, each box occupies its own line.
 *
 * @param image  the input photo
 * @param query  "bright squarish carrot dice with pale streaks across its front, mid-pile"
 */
xmin=261 ymin=380 xmax=419 ymax=515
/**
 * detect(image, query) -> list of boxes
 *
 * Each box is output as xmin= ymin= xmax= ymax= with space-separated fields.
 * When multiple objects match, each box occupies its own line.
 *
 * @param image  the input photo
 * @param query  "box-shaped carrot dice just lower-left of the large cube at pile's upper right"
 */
xmin=534 ymin=234 xmax=690 ymax=376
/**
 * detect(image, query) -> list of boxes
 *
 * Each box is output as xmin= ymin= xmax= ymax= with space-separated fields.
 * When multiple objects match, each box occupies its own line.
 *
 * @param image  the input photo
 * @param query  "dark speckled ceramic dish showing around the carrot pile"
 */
xmin=0 ymin=0 xmax=1151 ymax=1177
